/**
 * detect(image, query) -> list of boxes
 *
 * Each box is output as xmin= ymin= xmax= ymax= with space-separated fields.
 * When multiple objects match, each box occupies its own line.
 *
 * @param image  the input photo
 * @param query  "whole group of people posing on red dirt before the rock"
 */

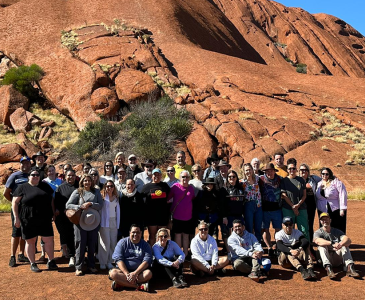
xmin=4 ymin=151 xmax=360 ymax=291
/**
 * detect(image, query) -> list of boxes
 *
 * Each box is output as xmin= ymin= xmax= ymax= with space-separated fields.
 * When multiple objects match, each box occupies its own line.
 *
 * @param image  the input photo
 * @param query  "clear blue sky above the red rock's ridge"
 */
xmin=276 ymin=0 xmax=365 ymax=35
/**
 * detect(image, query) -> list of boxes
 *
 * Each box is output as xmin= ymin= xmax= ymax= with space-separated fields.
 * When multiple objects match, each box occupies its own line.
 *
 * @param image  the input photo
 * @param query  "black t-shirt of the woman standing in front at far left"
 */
xmin=13 ymin=182 xmax=53 ymax=220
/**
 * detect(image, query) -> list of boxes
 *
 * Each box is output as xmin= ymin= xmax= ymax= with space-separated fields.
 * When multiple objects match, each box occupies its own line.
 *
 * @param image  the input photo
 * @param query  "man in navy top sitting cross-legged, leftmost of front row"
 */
xmin=109 ymin=224 xmax=152 ymax=292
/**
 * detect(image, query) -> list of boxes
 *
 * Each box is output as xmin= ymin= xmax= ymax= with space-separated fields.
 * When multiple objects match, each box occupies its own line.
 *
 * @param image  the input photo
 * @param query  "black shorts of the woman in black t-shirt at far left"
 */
xmin=20 ymin=218 xmax=54 ymax=240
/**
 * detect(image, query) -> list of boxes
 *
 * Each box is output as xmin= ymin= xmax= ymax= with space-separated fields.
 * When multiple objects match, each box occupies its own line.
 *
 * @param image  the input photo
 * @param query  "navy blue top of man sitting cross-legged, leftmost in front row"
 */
xmin=113 ymin=237 xmax=152 ymax=272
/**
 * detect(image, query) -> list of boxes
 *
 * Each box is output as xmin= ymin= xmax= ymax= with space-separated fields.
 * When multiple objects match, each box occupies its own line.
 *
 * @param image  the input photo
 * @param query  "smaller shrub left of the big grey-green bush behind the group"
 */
xmin=70 ymin=119 xmax=120 ymax=160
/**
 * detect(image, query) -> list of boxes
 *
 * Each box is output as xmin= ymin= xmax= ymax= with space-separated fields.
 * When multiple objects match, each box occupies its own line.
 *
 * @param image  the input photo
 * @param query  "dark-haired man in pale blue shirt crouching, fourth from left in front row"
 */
xmin=228 ymin=219 xmax=264 ymax=282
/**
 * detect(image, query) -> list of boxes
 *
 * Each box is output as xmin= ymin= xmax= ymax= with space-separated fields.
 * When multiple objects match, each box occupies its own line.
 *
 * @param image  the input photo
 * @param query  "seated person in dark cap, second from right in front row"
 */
xmin=275 ymin=217 xmax=317 ymax=280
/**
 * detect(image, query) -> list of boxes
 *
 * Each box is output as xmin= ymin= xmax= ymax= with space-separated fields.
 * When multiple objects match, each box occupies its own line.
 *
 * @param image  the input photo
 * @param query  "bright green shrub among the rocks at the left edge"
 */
xmin=1 ymin=64 xmax=44 ymax=99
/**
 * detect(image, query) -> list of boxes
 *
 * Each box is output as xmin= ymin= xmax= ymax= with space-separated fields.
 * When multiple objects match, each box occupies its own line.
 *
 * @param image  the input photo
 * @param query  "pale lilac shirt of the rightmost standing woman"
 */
xmin=316 ymin=178 xmax=347 ymax=212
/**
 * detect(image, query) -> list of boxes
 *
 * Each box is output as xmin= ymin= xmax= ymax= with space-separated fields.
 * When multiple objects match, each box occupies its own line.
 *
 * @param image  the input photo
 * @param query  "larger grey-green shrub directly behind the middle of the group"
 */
xmin=122 ymin=97 xmax=192 ymax=163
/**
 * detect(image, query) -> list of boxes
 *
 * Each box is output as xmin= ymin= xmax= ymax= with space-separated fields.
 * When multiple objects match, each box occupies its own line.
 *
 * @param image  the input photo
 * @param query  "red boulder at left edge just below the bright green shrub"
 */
xmin=0 ymin=85 xmax=29 ymax=126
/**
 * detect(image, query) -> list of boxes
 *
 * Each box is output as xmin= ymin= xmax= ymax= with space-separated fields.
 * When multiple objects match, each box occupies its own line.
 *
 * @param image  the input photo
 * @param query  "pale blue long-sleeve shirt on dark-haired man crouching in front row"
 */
xmin=228 ymin=230 xmax=263 ymax=262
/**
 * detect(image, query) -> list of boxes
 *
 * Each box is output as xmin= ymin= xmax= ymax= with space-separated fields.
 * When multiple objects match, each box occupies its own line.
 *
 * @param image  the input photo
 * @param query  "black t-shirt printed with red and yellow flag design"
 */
xmin=141 ymin=182 xmax=170 ymax=224
